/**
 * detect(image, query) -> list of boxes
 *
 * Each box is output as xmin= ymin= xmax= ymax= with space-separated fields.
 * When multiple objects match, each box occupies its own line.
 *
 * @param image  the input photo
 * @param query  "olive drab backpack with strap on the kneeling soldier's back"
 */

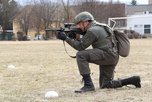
xmin=96 ymin=22 xmax=130 ymax=57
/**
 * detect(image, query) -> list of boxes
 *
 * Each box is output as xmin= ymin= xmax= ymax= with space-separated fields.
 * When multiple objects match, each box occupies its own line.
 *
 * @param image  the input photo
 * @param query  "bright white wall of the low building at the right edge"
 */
xmin=127 ymin=14 xmax=152 ymax=34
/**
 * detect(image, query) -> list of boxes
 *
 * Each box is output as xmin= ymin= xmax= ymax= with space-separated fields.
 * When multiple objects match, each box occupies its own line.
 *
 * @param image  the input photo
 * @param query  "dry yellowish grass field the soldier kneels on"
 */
xmin=0 ymin=39 xmax=152 ymax=102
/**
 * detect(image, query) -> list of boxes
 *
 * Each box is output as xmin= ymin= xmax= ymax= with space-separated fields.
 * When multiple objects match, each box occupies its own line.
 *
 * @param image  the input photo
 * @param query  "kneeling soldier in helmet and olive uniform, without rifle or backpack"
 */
xmin=58 ymin=12 xmax=141 ymax=93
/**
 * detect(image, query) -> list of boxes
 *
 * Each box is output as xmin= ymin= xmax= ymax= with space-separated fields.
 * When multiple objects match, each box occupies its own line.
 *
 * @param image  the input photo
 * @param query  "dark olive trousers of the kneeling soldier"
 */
xmin=76 ymin=49 xmax=119 ymax=83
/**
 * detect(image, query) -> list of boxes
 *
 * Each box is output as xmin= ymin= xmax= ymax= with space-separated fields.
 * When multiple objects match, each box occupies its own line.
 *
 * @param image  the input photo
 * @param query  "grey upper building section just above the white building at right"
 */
xmin=126 ymin=5 xmax=152 ymax=15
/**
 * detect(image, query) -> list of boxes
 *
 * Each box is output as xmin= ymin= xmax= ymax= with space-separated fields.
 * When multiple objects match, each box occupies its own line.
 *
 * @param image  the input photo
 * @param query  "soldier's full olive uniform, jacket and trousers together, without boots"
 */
xmin=66 ymin=21 xmax=119 ymax=83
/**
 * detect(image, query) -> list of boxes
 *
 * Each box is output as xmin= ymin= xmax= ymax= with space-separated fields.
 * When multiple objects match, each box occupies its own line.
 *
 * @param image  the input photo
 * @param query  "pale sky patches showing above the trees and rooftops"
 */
xmin=16 ymin=0 xmax=148 ymax=5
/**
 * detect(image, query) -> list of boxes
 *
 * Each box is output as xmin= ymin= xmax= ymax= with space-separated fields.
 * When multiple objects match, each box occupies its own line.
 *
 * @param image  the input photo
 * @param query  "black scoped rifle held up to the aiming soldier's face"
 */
xmin=45 ymin=23 xmax=84 ymax=39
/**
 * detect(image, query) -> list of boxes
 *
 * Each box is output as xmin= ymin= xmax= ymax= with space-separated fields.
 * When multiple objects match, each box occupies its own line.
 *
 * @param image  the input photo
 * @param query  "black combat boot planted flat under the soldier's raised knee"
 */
xmin=75 ymin=74 xmax=95 ymax=93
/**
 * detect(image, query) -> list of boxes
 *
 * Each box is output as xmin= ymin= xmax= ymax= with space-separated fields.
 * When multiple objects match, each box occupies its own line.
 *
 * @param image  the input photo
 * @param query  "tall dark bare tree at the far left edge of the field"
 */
xmin=0 ymin=0 xmax=18 ymax=40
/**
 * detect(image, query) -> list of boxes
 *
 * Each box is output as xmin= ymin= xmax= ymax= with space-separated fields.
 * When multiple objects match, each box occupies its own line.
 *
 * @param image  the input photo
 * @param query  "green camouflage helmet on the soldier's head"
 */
xmin=74 ymin=11 xmax=94 ymax=24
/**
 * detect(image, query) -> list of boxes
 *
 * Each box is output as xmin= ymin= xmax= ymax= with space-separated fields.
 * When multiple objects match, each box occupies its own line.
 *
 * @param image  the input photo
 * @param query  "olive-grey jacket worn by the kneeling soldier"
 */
xmin=65 ymin=21 xmax=115 ymax=51
